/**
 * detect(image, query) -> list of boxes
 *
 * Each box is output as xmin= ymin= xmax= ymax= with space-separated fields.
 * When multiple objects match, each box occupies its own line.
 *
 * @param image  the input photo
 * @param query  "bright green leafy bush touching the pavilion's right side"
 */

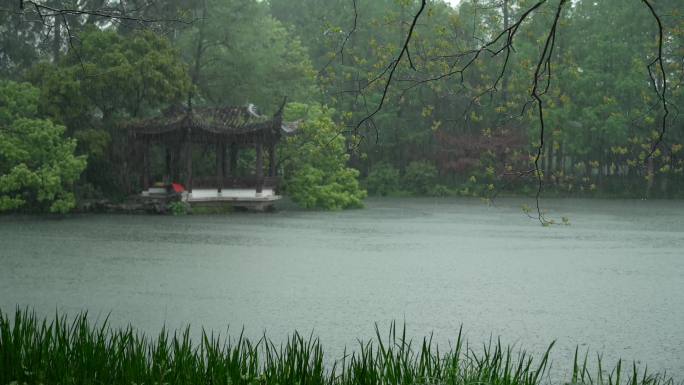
xmin=281 ymin=103 xmax=366 ymax=210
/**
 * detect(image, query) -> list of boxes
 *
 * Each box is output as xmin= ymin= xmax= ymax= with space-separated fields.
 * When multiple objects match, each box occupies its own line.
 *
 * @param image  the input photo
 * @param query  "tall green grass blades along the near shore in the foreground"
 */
xmin=0 ymin=309 xmax=675 ymax=385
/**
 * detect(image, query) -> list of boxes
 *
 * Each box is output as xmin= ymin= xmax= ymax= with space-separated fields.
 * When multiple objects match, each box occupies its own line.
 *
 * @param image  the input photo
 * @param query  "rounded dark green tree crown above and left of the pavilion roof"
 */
xmin=34 ymin=27 xmax=190 ymax=124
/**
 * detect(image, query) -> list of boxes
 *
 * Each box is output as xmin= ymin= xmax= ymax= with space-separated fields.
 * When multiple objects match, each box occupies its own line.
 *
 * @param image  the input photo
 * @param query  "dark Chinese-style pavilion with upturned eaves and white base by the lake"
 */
xmin=129 ymin=98 xmax=297 ymax=209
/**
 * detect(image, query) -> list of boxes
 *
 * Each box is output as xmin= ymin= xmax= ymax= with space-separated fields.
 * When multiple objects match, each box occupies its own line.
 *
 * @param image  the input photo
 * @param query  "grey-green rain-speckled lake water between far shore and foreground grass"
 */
xmin=0 ymin=199 xmax=684 ymax=379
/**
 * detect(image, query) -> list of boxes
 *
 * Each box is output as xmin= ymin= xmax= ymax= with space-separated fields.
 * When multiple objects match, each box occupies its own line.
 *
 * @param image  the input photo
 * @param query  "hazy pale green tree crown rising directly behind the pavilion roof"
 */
xmin=178 ymin=0 xmax=316 ymax=108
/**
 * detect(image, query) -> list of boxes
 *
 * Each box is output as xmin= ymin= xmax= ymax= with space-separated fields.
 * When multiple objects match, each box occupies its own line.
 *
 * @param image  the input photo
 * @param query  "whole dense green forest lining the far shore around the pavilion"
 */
xmin=0 ymin=0 xmax=684 ymax=212
